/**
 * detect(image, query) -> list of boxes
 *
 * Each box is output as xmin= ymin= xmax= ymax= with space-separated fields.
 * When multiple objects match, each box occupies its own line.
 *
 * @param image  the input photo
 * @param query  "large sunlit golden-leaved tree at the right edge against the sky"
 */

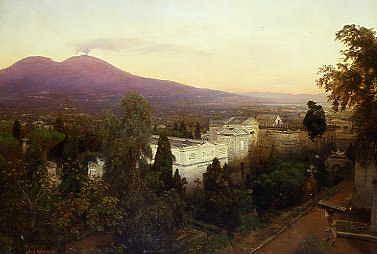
xmin=317 ymin=25 xmax=377 ymax=159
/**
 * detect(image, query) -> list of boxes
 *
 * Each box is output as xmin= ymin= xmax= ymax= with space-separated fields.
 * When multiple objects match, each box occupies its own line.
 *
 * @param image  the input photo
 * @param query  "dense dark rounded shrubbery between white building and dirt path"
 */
xmin=254 ymin=161 xmax=305 ymax=209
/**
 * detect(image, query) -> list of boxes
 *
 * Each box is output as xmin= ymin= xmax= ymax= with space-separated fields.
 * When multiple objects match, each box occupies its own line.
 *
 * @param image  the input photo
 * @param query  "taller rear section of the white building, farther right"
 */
xmin=203 ymin=117 xmax=259 ymax=161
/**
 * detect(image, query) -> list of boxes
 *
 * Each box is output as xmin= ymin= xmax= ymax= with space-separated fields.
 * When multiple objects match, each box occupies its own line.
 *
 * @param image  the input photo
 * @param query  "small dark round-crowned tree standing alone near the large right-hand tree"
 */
xmin=303 ymin=101 xmax=327 ymax=140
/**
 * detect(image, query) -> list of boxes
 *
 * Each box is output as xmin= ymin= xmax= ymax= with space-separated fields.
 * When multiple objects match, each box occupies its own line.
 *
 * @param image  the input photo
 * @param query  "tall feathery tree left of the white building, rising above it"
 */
xmin=103 ymin=94 xmax=152 ymax=196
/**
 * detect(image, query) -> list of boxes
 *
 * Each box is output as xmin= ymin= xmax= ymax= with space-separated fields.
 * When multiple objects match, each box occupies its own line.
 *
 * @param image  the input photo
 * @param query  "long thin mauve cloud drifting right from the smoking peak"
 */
xmin=74 ymin=38 xmax=210 ymax=56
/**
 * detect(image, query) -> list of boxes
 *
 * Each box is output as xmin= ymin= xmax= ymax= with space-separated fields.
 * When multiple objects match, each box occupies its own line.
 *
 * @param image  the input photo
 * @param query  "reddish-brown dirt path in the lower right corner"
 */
xmin=220 ymin=182 xmax=377 ymax=254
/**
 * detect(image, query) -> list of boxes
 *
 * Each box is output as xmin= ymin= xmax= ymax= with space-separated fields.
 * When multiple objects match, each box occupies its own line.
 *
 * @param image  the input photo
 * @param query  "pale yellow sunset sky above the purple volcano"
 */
xmin=0 ymin=0 xmax=377 ymax=93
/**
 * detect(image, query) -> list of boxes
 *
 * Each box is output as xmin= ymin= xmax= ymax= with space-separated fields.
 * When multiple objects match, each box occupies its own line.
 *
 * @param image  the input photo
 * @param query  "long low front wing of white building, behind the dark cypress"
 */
xmin=151 ymin=136 xmax=228 ymax=187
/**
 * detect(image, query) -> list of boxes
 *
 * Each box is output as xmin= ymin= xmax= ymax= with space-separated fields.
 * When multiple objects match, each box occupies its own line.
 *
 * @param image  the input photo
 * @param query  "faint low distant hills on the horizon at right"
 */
xmin=240 ymin=92 xmax=327 ymax=104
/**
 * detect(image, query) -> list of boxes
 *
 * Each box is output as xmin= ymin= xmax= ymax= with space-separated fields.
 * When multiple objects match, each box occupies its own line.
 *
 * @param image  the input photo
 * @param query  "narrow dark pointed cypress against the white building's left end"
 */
xmin=153 ymin=134 xmax=174 ymax=190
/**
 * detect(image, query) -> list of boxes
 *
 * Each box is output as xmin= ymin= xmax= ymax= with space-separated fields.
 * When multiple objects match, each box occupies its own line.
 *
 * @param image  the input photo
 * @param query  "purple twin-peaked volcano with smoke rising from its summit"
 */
xmin=0 ymin=56 xmax=250 ymax=111
